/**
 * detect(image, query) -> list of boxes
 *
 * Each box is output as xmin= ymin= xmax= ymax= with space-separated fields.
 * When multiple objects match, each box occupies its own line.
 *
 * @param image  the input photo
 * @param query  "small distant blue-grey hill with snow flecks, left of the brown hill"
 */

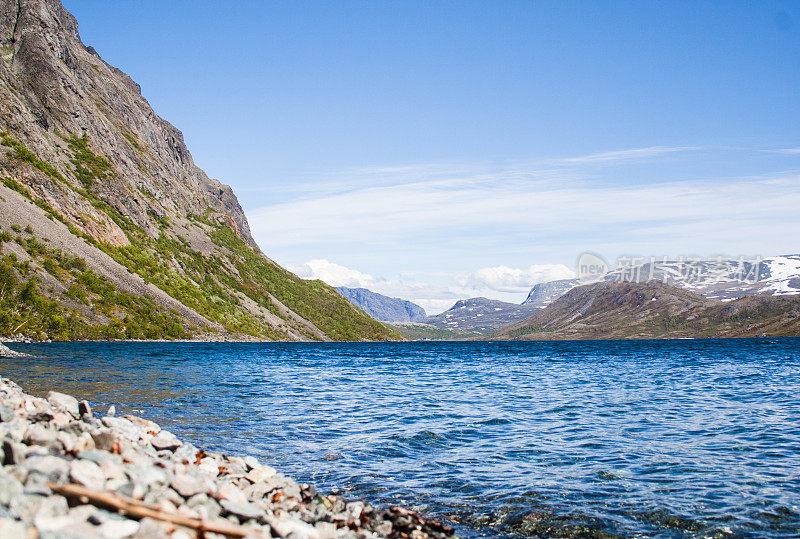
xmin=422 ymin=298 xmax=537 ymax=333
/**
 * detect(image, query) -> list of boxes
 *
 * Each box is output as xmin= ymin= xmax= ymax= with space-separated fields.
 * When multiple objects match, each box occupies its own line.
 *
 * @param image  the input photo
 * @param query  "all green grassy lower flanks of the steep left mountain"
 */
xmin=0 ymin=133 xmax=401 ymax=340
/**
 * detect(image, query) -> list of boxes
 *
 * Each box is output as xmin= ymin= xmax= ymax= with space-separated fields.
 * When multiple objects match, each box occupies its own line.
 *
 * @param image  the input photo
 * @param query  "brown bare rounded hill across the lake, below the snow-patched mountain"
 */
xmin=493 ymin=281 xmax=800 ymax=340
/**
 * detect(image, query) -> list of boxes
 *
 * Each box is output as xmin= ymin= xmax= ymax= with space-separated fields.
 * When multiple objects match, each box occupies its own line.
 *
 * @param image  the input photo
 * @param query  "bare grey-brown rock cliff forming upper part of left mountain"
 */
xmin=0 ymin=0 xmax=256 ymax=247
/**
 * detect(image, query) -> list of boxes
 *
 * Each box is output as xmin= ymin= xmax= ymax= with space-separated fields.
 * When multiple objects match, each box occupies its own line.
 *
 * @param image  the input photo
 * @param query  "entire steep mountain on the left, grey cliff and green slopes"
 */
xmin=0 ymin=0 xmax=399 ymax=340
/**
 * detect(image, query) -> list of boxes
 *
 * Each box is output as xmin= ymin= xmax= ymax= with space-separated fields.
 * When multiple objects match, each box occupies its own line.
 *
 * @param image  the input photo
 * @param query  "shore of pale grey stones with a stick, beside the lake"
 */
xmin=0 ymin=378 xmax=453 ymax=539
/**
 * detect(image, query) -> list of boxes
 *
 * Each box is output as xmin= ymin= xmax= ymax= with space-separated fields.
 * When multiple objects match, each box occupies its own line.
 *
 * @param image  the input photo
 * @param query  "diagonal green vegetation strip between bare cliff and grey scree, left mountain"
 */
xmin=2 ymin=134 xmax=402 ymax=340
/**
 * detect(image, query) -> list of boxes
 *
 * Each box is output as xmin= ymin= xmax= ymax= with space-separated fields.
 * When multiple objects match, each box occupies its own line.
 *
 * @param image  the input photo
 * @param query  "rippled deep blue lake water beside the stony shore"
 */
xmin=0 ymin=339 xmax=800 ymax=537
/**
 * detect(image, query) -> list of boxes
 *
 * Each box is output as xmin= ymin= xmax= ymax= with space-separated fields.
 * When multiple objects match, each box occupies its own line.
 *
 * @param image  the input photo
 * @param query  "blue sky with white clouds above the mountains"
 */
xmin=64 ymin=0 xmax=800 ymax=311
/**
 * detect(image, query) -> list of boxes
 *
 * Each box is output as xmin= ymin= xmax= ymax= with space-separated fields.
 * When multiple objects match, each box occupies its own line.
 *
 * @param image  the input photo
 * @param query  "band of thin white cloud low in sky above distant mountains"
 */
xmin=248 ymin=146 xmax=800 ymax=308
